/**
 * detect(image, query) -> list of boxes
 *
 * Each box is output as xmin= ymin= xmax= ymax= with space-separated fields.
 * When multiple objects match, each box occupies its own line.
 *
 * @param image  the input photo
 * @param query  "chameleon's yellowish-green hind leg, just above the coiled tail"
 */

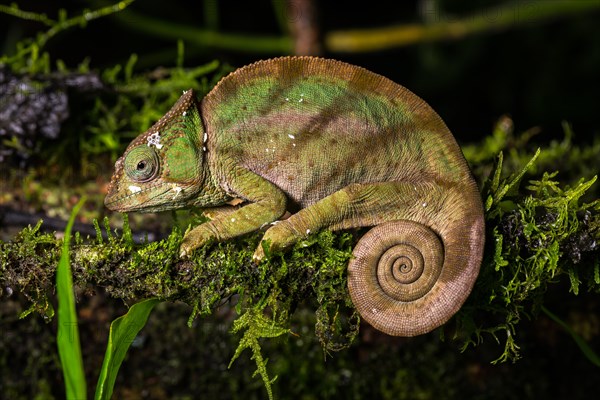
xmin=254 ymin=182 xmax=448 ymax=259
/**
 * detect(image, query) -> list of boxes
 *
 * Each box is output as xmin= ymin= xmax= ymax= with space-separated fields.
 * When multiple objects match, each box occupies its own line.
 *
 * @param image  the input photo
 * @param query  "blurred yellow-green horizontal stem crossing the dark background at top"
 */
xmin=108 ymin=0 xmax=600 ymax=54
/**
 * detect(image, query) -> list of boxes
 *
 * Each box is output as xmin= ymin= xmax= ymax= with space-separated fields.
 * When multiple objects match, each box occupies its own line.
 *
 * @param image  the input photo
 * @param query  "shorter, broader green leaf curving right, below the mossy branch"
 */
xmin=94 ymin=299 xmax=160 ymax=400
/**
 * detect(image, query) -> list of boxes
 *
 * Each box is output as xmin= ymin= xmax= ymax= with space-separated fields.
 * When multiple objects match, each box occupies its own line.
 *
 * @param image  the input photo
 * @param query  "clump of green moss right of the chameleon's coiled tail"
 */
xmin=457 ymin=136 xmax=600 ymax=361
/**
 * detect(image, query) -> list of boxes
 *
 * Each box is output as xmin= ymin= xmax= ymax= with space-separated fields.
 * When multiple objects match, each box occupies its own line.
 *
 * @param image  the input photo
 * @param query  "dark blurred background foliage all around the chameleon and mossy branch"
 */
xmin=0 ymin=0 xmax=600 ymax=399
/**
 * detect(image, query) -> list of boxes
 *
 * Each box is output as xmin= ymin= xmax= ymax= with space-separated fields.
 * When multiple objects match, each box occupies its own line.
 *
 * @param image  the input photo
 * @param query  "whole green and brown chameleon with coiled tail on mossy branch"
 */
xmin=105 ymin=56 xmax=485 ymax=336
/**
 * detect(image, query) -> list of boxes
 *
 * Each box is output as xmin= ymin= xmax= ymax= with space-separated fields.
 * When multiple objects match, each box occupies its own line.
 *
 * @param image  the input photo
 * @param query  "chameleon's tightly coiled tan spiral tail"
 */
xmin=348 ymin=220 xmax=483 ymax=336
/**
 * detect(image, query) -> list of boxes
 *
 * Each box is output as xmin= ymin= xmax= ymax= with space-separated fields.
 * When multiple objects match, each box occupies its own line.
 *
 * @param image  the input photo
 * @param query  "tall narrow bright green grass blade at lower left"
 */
xmin=56 ymin=198 xmax=87 ymax=400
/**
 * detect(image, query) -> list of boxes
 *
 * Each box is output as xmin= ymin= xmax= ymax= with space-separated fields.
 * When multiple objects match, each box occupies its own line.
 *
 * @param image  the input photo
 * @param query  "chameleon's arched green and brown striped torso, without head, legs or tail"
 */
xmin=201 ymin=57 xmax=471 ymax=207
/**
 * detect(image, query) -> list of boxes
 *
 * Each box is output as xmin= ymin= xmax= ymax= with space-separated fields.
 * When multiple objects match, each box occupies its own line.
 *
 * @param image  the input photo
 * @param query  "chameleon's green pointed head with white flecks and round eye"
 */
xmin=104 ymin=90 xmax=206 ymax=212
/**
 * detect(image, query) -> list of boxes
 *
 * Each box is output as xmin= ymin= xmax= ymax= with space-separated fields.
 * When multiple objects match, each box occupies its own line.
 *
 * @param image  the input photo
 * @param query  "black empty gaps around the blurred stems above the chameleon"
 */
xmin=0 ymin=0 xmax=600 ymax=141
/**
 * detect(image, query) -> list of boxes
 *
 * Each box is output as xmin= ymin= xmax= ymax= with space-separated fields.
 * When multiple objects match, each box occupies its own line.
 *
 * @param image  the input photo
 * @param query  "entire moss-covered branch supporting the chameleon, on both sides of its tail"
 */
xmin=0 ymin=134 xmax=600 ymax=397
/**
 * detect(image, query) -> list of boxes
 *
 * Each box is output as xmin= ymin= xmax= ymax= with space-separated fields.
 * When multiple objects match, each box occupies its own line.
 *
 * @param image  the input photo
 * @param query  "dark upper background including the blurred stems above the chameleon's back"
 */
xmin=0 ymin=0 xmax=600 ymax=145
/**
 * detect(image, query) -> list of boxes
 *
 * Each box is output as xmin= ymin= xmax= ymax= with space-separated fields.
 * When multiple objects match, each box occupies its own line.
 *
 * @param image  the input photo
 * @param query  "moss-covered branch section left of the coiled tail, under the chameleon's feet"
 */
xmin=0 ymin=219 xmax=355 ymax=348
